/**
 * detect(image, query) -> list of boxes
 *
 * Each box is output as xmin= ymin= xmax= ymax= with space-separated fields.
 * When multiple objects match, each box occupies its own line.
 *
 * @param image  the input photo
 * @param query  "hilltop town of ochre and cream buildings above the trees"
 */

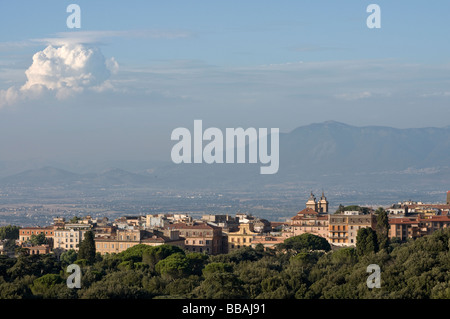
xmin=0 ymin=191 xmax=450 ymax=256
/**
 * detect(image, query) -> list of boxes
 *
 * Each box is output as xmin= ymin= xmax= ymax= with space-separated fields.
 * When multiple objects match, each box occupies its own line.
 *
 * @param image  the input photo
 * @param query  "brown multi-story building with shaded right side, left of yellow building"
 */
xmin=168 ymin=221 xmax=226 ymax=255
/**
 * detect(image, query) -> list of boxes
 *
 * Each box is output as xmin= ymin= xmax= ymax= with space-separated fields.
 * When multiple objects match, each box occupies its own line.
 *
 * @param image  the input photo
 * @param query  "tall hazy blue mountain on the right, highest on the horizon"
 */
xmin=280 ymin=121 xmax=450 ymax=175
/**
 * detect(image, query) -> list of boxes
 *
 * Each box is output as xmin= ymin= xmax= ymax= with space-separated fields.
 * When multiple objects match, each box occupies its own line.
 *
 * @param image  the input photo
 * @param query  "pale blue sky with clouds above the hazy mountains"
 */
xmin=0 ymin=0 xmax=450 ymax=168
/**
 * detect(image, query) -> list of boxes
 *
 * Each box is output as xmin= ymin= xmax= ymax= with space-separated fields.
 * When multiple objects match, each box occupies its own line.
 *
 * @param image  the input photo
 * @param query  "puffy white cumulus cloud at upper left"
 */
xmin=0 ymin=44 xmax=118 ymax=107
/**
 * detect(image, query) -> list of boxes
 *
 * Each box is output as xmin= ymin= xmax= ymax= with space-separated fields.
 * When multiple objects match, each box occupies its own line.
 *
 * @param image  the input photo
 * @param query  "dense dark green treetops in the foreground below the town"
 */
xmin=0 ymin=225 xmax=450 ymax=299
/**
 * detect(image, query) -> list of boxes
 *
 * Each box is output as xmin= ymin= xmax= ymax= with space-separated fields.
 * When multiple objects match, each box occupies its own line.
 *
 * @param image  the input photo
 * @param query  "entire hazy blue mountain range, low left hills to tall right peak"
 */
xmin=0 ymin=121 xmax=450 ymax=189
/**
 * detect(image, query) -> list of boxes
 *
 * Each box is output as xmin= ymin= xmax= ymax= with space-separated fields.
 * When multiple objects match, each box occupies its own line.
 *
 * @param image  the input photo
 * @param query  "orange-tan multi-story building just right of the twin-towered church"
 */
xmin=328 ymin=212 xmax=376 ymax=246
